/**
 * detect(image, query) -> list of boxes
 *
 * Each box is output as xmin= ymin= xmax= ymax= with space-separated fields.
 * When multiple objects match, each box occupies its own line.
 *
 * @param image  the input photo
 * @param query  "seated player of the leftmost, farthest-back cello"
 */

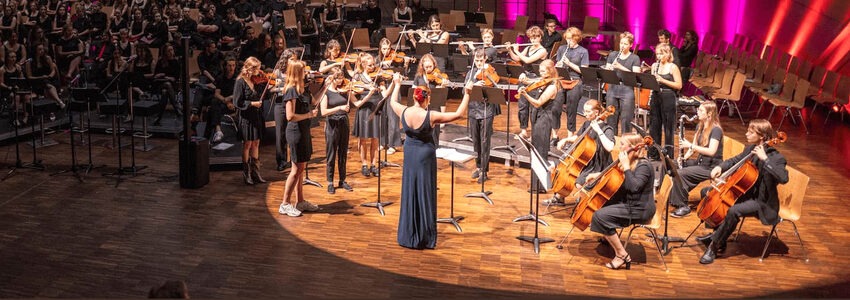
xmin=543 ymin=99 xmax=616 ymax=205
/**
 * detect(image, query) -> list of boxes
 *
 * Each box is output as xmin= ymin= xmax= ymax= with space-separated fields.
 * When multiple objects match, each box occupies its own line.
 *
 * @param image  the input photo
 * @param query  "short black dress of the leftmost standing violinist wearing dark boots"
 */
xmin=233 ymin=77 xmax=265 ymax=141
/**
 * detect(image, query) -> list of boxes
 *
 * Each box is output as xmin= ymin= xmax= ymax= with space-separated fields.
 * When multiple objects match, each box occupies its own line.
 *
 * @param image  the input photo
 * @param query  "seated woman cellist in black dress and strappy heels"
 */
xmin=587 ymin=133 xmax=655 ymax=269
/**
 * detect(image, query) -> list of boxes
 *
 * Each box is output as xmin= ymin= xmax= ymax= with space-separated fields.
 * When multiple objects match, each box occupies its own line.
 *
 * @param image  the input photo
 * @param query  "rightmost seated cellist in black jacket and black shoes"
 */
xmin=697 ymin=119 xmax=788 ymax=264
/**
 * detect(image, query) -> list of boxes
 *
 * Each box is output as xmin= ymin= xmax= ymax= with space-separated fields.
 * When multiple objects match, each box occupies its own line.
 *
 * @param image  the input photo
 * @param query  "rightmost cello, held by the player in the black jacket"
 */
xmin=697 ymin=132 xmax=788 ymax=228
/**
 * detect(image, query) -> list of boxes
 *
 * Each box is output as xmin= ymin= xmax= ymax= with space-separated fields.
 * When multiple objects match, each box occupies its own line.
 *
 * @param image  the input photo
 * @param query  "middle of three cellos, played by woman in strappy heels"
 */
xmin=570 ymin=136 xmax=653 ymax=231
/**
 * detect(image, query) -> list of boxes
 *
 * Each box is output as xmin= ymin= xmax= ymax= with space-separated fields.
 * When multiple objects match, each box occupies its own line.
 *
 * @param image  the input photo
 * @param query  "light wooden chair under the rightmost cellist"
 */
xmin=735 ymin=166 xmax=809 ymax=262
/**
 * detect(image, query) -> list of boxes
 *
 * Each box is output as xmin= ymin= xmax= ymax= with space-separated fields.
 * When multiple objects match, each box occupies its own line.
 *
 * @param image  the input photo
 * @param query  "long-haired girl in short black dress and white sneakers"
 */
xmin=278 ymin=60 xmax=319 ymax=217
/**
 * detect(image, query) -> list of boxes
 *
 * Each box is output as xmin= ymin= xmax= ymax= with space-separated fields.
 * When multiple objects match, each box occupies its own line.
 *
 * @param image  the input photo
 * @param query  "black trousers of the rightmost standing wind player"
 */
xmin=649 ymin=90 xmax=676 ymax=150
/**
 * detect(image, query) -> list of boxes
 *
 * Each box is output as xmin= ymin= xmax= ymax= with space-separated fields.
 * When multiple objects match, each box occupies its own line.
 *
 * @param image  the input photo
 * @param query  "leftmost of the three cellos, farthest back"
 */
xmin=552 ymin=106 xmax=615 ymax=197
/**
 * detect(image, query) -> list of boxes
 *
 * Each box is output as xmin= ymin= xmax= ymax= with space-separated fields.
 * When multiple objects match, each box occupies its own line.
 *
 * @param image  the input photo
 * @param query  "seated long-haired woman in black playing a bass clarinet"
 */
xmin=669 ymin=101 xmax=723 ymax=218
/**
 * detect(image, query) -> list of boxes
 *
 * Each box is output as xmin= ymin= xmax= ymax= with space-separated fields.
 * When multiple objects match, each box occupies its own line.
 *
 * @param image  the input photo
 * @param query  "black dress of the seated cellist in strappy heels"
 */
xmin=590 ymin=159 xmax=655 ymax=235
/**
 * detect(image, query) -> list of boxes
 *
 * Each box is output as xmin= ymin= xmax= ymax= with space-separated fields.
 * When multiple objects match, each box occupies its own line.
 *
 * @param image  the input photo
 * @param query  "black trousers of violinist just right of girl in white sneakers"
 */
xmin=325 ymin=116 xmax=351 ymax=184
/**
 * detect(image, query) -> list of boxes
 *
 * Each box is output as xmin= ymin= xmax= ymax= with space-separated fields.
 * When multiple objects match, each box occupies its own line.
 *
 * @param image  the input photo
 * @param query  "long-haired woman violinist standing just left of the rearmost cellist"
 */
xmin=519 ymin=59 xmax=560 ymax=186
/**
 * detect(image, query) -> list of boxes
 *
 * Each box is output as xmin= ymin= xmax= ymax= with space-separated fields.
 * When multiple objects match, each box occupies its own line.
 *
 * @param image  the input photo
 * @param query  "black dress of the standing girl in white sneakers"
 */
xmin=283 ymin=87 xmax=313 ymax=163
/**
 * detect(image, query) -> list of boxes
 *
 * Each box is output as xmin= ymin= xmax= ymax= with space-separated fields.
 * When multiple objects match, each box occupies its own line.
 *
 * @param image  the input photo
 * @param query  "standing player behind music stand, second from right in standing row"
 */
xmin=605 ymin=31 xmax=640 ymax=134
